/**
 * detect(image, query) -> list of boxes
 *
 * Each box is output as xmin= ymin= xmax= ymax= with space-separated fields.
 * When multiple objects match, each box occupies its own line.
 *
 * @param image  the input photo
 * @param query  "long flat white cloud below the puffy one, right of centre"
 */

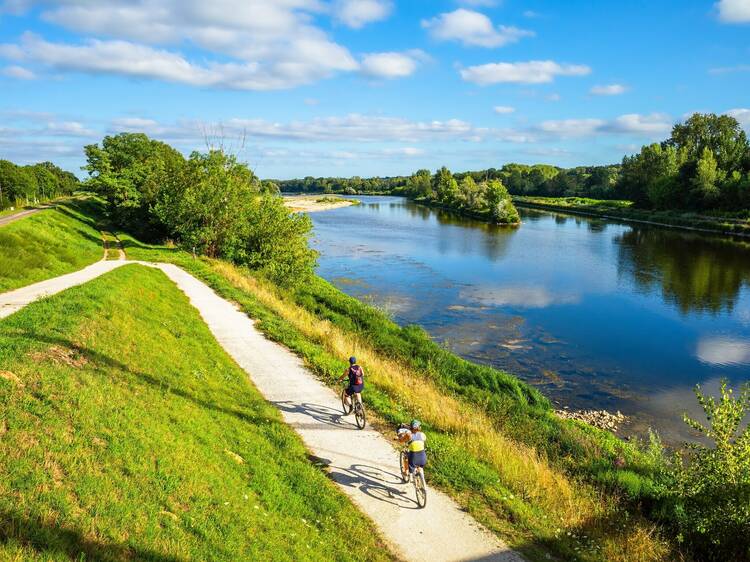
xmin=460 ymin=60 xmax=591 ymax=86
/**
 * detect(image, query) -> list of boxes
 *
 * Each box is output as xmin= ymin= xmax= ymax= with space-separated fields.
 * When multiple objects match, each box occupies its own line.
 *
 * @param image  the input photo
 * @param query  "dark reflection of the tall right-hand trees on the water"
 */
xmin=615 ymin=227 xmax=750 ymax=314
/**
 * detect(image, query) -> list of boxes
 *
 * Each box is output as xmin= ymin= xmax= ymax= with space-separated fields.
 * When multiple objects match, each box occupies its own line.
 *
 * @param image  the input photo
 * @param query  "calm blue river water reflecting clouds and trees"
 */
xmin=311 ymin=197 xmax=750 ymax=443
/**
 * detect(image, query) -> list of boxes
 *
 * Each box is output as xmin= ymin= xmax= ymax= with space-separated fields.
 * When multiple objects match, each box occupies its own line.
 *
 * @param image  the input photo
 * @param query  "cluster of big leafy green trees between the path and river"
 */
xmin=84 ymin=133 xmax=316 ymax=285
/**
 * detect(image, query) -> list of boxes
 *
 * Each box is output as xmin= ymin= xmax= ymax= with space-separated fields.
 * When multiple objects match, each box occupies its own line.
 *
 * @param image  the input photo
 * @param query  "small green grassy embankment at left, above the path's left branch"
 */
xmin=0 ymin=199 xmax=103 ymax=292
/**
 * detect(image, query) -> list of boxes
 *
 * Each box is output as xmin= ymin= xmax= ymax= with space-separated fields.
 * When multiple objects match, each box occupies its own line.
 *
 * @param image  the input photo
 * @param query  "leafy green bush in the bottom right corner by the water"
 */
xmin=668 ymin=381 xmax=750 ymax=562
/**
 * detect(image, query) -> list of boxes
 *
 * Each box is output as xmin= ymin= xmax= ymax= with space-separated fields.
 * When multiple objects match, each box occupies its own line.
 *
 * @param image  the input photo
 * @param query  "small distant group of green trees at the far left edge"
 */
xmin=0 ymin=160 xmax=80 ymax=210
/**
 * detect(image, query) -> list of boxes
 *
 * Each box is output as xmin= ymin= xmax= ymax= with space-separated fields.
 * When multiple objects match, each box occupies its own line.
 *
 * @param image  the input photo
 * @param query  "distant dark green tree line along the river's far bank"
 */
xmin=277 ymin=113 xmax=750 ymax=211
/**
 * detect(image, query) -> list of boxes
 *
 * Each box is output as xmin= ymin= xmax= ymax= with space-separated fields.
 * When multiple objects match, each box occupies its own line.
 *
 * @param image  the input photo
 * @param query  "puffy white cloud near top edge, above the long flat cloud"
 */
xmin=422 ymin=8 xmax=534 ymax=47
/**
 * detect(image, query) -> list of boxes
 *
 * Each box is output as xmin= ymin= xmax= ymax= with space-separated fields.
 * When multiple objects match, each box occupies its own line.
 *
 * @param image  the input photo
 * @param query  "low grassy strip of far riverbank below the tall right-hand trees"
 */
xmin=513 ymin=196 xmax=750 ymax=237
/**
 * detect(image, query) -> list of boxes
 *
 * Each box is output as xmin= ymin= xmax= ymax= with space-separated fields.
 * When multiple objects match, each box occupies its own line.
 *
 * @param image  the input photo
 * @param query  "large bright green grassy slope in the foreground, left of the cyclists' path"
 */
xmin=0 ymin=265 xmax=389 ymax=561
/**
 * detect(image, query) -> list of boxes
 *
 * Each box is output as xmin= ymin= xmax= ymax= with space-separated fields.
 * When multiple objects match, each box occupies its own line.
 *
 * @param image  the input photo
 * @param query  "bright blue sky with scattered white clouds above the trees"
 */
xmin=0 ymin=0 xmax=750 ymax=179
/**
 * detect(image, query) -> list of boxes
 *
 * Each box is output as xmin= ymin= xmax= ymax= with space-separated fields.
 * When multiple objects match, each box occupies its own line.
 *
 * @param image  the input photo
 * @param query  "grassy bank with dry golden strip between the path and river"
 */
xmin=121 ymin=235 xmax=669 ymax=560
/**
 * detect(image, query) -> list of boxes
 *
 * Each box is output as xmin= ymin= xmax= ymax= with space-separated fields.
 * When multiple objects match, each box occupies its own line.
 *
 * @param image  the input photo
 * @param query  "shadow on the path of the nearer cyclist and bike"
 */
xmin=328 ymin=464 xmax=419 ymax=509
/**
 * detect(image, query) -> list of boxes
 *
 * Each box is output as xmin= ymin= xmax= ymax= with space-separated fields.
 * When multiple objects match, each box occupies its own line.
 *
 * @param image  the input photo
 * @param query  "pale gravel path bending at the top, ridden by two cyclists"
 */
xmin=0 ymin=261 xmax=523 ymax=562
